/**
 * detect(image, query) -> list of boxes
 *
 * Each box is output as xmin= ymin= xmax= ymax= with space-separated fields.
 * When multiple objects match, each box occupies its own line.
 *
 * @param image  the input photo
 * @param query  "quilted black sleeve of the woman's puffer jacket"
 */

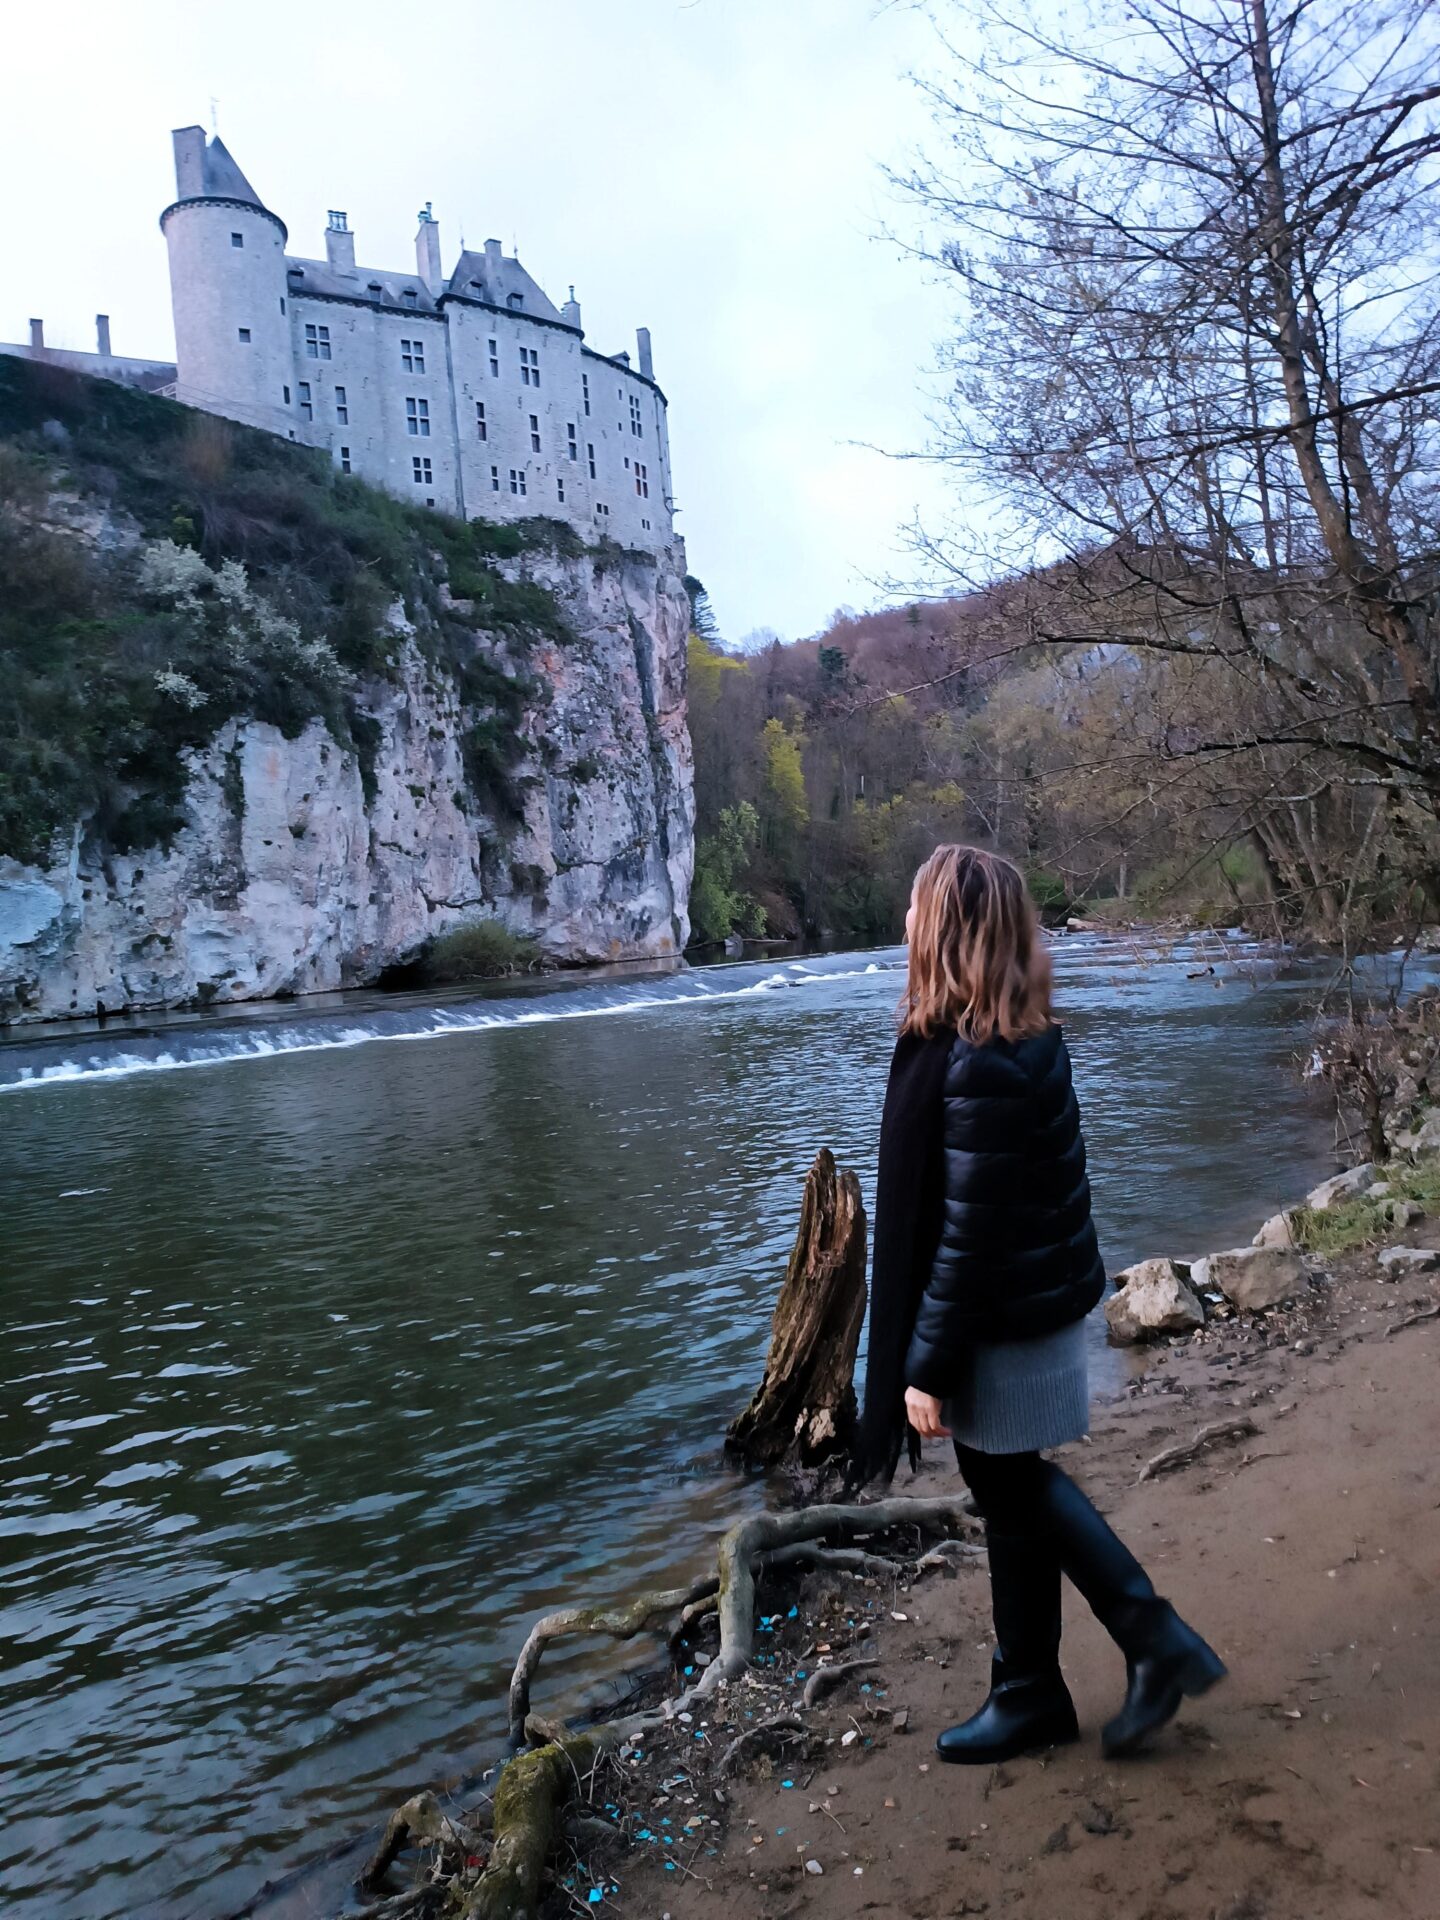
xmin=904 ymin=1039 xmax=1037 ymax=1400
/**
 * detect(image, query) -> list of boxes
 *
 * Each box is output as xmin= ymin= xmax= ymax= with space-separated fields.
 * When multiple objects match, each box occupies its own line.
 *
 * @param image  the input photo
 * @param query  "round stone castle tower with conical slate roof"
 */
xmin=159 ymin=127 xmax=296 ymax=434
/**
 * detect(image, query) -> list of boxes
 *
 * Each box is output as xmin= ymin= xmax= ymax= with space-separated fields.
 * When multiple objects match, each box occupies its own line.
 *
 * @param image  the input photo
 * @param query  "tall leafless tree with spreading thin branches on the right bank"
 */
xmin=908 ymin=0 xmax=1440 ymax=920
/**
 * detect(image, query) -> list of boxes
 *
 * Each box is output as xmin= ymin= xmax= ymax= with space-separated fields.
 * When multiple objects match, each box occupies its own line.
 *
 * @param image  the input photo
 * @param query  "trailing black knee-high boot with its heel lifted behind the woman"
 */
xmin=1043 ymin=1465 xmax=1225 ymax=1759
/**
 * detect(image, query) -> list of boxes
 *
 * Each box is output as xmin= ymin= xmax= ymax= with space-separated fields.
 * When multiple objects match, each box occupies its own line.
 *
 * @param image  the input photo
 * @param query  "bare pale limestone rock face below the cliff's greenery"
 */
xmin=0 ymin=547 xmax=695 ymax=1020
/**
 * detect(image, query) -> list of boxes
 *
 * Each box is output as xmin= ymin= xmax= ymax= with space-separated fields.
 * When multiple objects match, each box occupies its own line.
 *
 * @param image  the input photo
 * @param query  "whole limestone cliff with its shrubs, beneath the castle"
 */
xmin=0 ymin=361 xmax=695 ymax=1023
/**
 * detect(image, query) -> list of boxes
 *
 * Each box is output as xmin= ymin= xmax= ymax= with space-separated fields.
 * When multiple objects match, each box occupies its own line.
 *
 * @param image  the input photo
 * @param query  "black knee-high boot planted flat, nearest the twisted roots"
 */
xmin=935 ymin=1526 xmax=1079 ymax=1766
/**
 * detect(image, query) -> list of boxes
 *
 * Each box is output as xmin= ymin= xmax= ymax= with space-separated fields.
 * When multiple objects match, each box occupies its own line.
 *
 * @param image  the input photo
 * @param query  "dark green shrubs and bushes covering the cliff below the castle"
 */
xmin=0 ymin=359 xmax=580 ymax=862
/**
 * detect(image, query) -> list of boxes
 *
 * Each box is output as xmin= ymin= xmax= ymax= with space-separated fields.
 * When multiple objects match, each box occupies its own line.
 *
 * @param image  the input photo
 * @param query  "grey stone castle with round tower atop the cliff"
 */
xmin=0 ymin=127 xmax=674 ymax=551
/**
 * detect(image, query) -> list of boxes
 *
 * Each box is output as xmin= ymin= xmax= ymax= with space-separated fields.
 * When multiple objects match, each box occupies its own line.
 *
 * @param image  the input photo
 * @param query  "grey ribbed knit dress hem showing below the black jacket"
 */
xmin=943 ymin=1319 xmax=1091 ymax=1453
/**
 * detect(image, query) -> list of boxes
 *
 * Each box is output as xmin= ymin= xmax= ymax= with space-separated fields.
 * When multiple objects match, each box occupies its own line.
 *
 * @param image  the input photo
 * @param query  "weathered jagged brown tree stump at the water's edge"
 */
xmin=726 ymin=1146 xmax=866 ymax=1467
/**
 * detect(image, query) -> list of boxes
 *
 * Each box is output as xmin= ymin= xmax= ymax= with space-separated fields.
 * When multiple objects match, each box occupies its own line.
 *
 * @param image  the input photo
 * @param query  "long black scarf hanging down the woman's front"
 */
xmin=851 ymin=1029 xmax=954 ymax=1486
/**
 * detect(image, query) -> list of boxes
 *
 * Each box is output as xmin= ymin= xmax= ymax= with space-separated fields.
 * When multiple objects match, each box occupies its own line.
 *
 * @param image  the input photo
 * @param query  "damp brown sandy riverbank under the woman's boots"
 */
xmin=622 ymin=1221 xmax=1440 ymax=1920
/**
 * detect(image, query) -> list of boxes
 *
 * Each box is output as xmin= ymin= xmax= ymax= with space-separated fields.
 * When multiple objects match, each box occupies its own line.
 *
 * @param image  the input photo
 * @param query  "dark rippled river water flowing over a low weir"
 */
xmin=0 ymin=941 xmax=1331 ymax=1920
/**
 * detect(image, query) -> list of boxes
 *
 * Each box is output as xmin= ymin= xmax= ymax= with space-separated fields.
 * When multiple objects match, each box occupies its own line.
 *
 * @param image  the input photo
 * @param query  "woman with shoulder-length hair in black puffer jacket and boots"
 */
xmin=860 ymin=847 xmax=1225 ymax=1766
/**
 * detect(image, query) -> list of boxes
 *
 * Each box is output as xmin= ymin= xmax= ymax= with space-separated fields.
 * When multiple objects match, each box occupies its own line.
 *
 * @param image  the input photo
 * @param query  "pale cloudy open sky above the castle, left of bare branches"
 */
xmin=0 ymin=0 xmax=971 ymax=641
